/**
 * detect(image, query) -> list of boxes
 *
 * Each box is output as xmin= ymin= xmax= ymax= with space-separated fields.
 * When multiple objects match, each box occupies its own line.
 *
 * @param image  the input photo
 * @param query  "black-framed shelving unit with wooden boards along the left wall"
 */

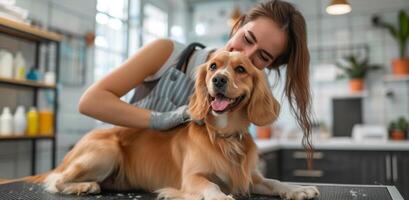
xmin=0 ymin=17 xmax=63 ymax=174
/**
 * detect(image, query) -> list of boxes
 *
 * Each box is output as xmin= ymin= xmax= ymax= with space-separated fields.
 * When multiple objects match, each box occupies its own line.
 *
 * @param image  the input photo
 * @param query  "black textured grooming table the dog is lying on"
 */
xmin=0 ymin=182 xmax=403 ymax=200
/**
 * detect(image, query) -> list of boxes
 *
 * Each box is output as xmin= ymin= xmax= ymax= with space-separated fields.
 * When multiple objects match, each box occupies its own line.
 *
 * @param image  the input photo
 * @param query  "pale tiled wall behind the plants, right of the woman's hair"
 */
xmin=306 ymin=1 xmax=409 ymax=134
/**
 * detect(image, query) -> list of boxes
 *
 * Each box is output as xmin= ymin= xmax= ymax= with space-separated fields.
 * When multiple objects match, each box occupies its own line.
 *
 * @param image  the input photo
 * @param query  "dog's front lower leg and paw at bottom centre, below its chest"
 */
xmin=182 ymin=174 xmax=234 ymax=200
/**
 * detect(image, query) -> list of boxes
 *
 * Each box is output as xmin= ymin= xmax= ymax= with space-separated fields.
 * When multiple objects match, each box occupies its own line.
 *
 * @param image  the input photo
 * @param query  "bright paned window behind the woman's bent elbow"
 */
xmin=94 ymin=0 xmax=168 ymax=94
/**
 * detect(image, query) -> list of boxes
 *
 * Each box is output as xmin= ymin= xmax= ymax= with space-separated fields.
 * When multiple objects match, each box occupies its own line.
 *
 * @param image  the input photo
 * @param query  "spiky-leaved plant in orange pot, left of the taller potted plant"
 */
xmin=336 ymin=54 xmax=381 ymax=92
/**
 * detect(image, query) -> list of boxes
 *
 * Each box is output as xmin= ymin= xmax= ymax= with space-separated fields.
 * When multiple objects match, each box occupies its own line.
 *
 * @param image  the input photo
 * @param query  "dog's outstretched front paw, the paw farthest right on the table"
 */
xmin=280 ymin=186 xmax=320 ymax=200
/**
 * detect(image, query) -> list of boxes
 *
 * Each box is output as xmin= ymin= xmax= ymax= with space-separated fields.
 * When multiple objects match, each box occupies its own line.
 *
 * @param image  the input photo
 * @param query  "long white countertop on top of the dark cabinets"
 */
xmin=255 ymin=137 xmax=409 ymax=153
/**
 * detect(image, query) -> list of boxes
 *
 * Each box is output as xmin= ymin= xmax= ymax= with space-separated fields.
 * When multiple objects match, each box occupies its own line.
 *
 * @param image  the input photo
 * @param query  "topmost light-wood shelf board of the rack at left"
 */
xmin=0 ymin=17 xmax=64 ymax=42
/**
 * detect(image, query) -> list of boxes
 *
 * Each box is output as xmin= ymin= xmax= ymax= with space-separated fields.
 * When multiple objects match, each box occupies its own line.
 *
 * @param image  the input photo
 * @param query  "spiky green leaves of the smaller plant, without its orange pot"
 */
xmin=335 ymin=54 xmax=382 ymax=79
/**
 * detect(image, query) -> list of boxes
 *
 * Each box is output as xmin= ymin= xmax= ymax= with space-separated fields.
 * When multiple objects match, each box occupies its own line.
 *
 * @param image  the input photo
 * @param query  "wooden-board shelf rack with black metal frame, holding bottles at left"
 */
xmin=0 ymin=17 xmax=60 ymax=175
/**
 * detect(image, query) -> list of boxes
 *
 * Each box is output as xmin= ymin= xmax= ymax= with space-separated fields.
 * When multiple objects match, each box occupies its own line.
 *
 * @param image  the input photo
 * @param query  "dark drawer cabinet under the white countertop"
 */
xmin=279 ymin=149 xmax=409 ymax=199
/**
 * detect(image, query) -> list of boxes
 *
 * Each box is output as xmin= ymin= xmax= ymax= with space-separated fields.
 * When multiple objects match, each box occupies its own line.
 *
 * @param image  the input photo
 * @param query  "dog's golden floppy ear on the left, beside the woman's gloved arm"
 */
xmin=189 ymin=64 xmax=210 ymax=120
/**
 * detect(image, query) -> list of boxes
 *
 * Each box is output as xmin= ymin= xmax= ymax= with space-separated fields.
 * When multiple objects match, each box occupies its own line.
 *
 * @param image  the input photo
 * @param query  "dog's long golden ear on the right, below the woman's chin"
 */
xmin=247 ymin=71 xmax=280 ymax=126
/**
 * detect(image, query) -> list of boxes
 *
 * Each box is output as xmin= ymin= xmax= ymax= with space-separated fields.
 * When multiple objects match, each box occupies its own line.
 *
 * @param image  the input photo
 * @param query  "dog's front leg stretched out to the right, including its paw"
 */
xmin=251 ymin=171 xmax=320 ymax=200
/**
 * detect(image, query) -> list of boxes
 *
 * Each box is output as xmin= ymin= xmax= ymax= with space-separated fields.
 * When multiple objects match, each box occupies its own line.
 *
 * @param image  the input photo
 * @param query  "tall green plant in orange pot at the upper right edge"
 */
xmin=372 ymin=10 xmax=409 ymax=75
